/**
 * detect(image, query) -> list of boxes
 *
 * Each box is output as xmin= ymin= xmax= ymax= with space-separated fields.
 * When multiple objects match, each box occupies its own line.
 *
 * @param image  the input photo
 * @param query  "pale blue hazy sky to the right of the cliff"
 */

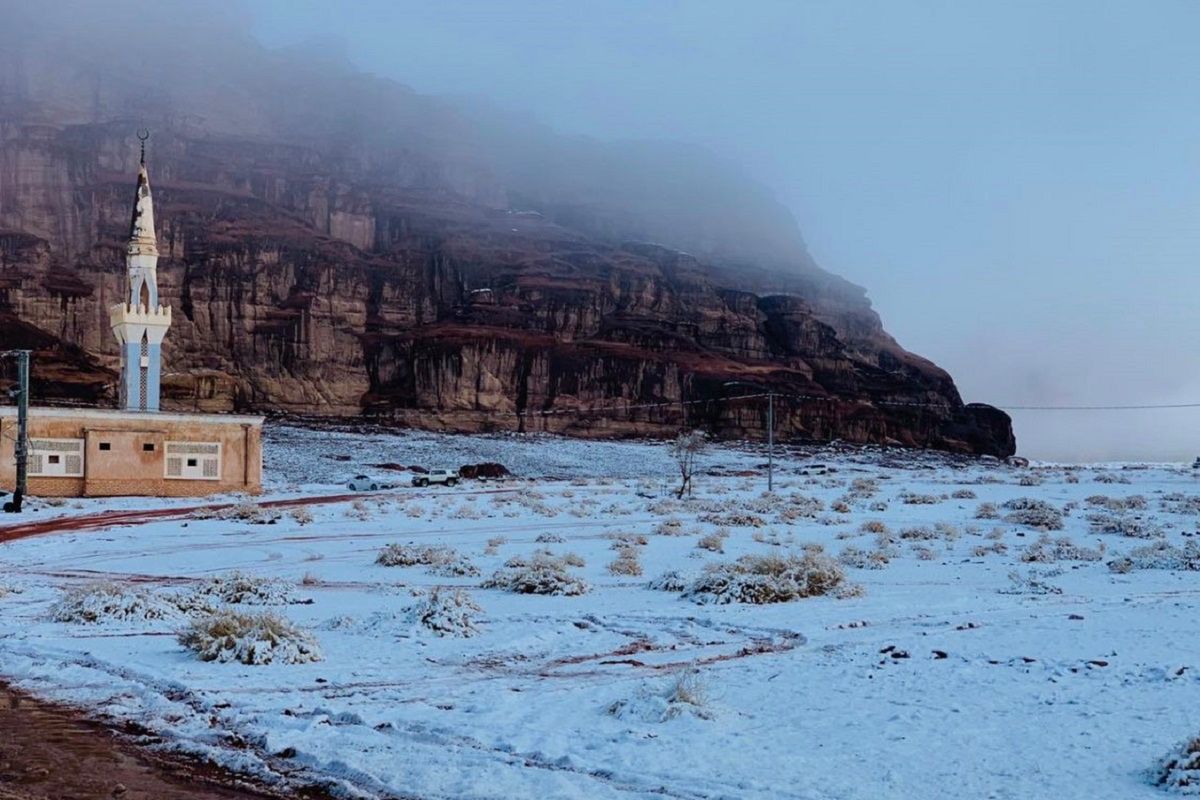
xmin=250 ymin=0 xmax=1200 ymax=458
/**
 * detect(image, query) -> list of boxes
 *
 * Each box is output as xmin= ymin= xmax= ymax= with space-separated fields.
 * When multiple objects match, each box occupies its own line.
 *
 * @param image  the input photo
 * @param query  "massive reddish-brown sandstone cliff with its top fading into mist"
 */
xmin=0 ymin=7 xmax=1014 ymax=455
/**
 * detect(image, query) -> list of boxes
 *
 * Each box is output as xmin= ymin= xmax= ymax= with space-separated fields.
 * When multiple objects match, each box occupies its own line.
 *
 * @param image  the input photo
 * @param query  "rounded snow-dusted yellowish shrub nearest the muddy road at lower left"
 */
xmin=179 ymin=609 xmax=322 ymax=664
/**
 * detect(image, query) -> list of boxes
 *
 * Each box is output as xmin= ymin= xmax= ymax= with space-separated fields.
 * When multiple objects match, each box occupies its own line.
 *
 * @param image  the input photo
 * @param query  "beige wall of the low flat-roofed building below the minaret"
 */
xmin=0 ymin=409 xmax=263 ymax=497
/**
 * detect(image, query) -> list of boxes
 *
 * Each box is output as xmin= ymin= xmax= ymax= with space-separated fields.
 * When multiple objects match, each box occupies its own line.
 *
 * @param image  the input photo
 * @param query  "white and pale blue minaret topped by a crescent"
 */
xmin=108 ymin=132 xmax=170 ymax=411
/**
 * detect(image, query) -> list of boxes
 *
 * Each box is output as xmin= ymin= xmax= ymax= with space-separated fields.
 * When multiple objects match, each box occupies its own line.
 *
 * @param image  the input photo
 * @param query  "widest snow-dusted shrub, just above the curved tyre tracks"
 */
xmin=684 ymin=553 xmax=846 ymax=604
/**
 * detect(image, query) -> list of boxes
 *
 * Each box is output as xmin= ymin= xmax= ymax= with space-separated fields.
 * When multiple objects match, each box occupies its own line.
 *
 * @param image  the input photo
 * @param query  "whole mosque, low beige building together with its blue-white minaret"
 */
xmin=0 ymin=142 xmax=263 ymax=497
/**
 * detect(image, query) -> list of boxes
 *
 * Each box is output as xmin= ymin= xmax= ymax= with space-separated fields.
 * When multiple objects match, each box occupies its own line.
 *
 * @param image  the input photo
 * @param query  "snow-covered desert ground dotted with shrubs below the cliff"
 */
xmin=0 ymin=428 xmax=1200 ymax=800
